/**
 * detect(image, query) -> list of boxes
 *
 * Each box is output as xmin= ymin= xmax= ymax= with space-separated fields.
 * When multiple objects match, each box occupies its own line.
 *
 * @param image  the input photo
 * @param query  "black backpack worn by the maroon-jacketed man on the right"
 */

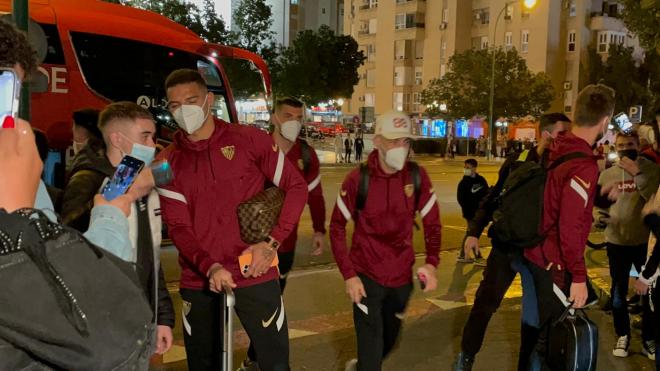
xmin=491 ymin=151 xmax=587 ymax=249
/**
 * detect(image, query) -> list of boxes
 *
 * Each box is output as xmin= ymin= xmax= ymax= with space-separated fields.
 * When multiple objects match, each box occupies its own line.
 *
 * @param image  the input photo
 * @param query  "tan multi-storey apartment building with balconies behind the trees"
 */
xmin=344 ymin=0 xmax=643 ymax=114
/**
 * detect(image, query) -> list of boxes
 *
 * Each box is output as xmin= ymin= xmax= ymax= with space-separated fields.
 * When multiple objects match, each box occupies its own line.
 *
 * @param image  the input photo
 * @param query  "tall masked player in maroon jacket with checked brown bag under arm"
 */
xmin=158 ymin=69 xmax=308 ymax=371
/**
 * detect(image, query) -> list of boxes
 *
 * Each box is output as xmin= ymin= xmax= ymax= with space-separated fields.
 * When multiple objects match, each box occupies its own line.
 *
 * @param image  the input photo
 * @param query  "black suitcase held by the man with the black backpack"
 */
xmin=546 ymin=286 xmax=598 ymax=371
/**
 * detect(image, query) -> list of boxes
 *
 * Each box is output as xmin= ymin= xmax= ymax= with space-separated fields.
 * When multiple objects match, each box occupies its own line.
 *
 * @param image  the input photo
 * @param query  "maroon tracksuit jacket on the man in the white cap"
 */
xmin=330 ymin=150 xmax=442 ymax=287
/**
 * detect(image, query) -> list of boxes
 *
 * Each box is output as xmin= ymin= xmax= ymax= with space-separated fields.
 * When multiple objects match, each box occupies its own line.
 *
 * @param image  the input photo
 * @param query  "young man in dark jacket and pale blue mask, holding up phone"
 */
xmin=62 ymin=102 xmax=175 ymax=354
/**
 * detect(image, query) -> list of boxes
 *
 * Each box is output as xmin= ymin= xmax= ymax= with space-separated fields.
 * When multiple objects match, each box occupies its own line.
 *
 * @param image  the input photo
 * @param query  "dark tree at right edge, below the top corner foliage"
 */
xmin=588 ymin=44 xmax=660 ymax=119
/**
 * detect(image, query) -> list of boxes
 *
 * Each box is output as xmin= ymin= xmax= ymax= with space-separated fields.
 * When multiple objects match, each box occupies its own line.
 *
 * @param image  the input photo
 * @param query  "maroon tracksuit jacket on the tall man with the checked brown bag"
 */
xmin=158 ymin=120 xmax=307 ymax=289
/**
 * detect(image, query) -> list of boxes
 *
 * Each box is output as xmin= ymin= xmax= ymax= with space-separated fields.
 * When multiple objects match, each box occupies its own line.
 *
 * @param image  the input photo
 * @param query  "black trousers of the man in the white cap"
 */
xmin=353 ymin=275 xmax=412 ymax=371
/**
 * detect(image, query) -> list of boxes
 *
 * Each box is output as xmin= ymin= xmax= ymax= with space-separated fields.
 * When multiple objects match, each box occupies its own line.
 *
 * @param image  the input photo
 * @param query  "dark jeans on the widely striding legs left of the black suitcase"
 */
xmin=461 ymin=241 xmax=538 ymax=370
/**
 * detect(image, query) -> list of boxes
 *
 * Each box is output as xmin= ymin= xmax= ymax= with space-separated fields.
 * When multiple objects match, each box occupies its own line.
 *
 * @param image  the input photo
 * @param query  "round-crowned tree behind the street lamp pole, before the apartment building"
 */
xmin=421 ymin=49 xmax=555 ymax=119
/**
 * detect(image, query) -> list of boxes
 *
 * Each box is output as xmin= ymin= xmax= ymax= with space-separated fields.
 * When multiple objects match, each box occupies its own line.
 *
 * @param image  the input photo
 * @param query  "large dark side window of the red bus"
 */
xmin=71 ymin=32 xmax=230 ymax=121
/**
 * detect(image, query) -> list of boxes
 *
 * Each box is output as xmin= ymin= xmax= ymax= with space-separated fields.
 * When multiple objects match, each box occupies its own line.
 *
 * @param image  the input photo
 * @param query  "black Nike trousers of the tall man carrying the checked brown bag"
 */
xmin=180 ymin=280 xmax=289 ymax=371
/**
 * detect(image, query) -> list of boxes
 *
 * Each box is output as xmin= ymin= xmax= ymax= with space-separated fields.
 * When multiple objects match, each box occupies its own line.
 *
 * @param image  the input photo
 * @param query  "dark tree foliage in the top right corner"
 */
xmin=621 ymin=0 xmax=660 ymax=53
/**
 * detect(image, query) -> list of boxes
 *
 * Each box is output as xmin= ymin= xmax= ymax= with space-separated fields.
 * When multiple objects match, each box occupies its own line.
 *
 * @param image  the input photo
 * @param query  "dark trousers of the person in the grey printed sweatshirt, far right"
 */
xmin=607 ymin=243 xmax=653 ymax=340
